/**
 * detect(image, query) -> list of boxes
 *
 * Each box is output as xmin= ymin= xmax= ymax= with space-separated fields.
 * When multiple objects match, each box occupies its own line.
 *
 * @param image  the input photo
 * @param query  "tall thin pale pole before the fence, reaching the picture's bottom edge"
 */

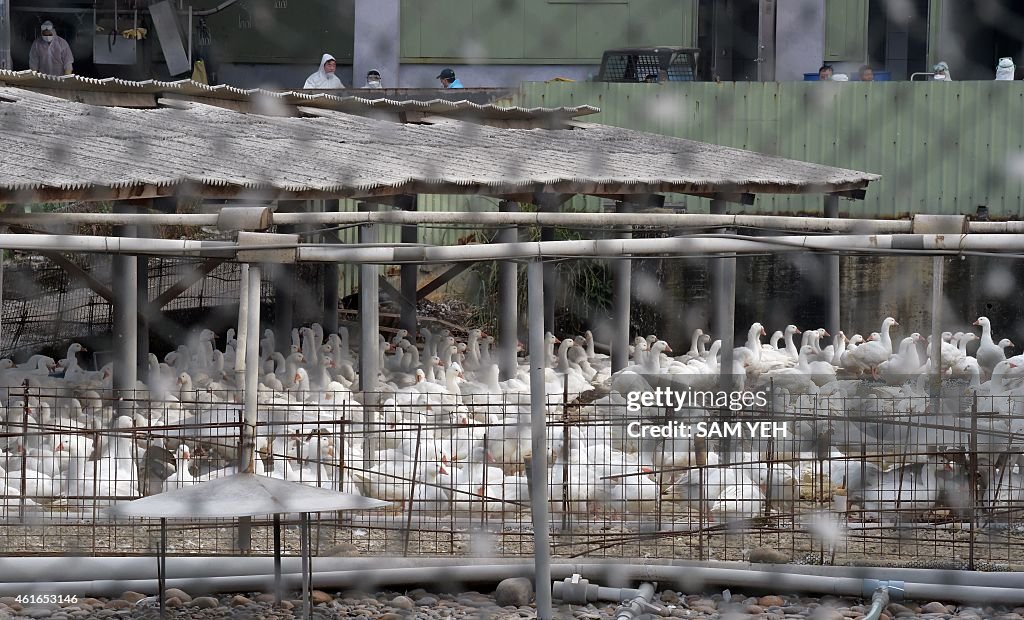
xmin=526 ymin=260 xmax=552 ymax=620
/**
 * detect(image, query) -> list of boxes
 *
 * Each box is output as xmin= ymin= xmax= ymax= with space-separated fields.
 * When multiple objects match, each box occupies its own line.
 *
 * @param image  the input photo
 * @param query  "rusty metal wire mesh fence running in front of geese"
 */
xmin=0 ymin=381 xmax=1024 ymax=570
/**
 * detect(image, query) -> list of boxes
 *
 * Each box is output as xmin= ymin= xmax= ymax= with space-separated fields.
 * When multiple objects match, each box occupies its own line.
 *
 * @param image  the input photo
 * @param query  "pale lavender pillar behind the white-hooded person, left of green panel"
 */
xmin=351 ymin=0 xmax=399 ymax=88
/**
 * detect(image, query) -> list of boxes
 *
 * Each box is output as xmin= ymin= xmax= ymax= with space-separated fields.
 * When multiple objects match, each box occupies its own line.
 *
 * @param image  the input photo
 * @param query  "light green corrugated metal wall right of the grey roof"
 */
xmin=514 ymin=81 xmax=1024 ymax=218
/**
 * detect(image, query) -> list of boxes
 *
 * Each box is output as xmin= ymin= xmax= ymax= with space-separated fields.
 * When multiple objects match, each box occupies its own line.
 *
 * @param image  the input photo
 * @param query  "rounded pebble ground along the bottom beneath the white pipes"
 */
xmin=0 ymin=589 xmax=1024 ymax=620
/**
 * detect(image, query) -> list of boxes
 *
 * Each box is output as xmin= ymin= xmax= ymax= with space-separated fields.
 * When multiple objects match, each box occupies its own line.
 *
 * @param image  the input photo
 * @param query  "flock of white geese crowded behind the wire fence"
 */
xmin=0 ymin=317 xmax=1024 ymax=521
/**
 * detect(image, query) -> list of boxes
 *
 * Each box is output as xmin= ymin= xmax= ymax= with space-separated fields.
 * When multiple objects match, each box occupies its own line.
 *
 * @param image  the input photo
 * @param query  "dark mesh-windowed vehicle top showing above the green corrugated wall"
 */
xmin=597 ymin=46 xmax=703 ymax=83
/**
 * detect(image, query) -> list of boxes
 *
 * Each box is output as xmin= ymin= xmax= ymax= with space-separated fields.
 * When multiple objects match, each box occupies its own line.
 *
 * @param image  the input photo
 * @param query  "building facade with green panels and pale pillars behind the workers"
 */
xmin=0 ymin=0 xmax=1024 ymax=88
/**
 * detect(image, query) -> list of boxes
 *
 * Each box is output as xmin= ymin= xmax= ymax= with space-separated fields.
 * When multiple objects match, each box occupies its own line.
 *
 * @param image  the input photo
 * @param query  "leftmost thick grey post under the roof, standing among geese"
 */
xmin=111 ymin=203 xmax=138 ymax=416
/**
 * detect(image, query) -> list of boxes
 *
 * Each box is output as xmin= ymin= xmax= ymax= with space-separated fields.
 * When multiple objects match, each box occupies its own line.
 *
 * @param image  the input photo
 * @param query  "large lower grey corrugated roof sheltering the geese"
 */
xmin=0 ymin=87 xmax=879 ymax=202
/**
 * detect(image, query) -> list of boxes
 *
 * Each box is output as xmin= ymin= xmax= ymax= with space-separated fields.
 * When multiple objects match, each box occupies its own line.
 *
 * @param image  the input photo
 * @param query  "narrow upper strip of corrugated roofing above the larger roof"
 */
xmin=0 ymin=70 xmax=600 ymax=120
